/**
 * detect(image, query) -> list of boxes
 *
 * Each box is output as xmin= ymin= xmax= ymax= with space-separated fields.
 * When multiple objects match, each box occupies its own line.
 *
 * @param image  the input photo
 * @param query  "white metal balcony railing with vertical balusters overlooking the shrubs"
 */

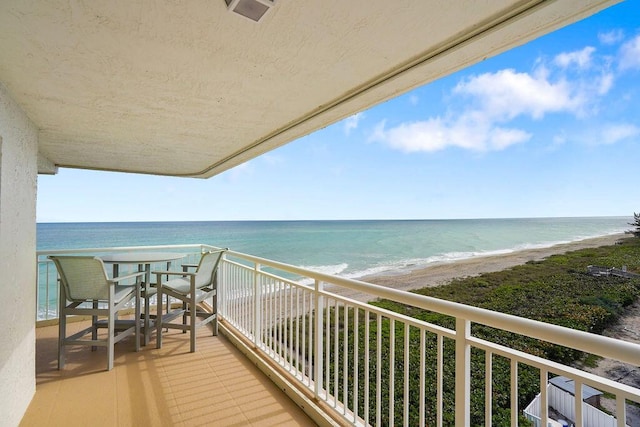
xmin=38 ymin=245 xmax=640 ymax=426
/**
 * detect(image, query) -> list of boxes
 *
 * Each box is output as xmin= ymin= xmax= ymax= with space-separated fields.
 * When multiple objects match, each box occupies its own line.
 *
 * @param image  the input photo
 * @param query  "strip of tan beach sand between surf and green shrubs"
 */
xmin=331 ymin=233 xmax=630 ymax=302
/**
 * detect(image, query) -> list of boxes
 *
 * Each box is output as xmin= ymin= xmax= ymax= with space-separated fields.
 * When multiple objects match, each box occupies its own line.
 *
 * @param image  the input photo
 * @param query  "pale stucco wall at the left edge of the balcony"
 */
xmin=0 ymin=83 xmax=38 ymax=426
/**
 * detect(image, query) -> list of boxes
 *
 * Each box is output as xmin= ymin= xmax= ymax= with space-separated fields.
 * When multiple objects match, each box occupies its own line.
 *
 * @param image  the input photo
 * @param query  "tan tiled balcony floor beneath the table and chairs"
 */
xmin=21 ymin=323 xmax=315 ymax=427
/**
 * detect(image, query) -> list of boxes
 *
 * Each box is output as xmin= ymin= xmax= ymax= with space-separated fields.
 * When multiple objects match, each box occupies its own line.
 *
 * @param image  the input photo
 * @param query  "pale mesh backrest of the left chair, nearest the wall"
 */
xmin=49 ymin=256 xmax=109 ymax=301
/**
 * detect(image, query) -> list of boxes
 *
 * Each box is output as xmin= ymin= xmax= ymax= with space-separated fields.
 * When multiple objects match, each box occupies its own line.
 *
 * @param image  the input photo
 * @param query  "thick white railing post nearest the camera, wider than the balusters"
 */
xmin=456 ymin=317 xmax=471 ymax=427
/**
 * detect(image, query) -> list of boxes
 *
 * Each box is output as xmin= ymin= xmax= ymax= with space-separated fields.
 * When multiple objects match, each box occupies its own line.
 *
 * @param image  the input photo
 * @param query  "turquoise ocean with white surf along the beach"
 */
xmin=37 ymin=217 xmax=633 ymax=278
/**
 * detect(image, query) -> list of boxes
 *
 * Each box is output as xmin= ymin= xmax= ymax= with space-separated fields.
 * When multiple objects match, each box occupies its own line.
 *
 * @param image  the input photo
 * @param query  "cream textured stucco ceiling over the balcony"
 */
xmin=0 ymin=0 xmax=616 ymax=177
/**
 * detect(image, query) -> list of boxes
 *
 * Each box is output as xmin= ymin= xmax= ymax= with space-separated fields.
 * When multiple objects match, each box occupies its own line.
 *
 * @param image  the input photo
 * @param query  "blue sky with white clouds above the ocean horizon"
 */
xmin=37 ymin=0 xmax=640 ymax=222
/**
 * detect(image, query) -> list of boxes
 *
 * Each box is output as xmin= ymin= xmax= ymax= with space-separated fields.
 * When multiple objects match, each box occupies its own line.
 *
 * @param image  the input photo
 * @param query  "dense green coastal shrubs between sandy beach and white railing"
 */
xmin=304 ymin=236 xmax=640 ymax=426
